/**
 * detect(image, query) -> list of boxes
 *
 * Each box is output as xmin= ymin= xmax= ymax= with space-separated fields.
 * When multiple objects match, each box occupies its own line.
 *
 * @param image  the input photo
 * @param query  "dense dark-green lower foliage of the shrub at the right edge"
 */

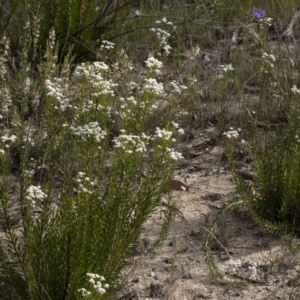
xmin=238 ymin=116 xmax=300 ymax=232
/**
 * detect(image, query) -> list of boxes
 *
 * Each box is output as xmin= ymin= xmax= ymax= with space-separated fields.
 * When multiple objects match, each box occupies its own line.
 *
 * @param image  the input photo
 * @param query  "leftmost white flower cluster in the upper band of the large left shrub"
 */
xmin=45 ymin=78 xmax=72 ymax=111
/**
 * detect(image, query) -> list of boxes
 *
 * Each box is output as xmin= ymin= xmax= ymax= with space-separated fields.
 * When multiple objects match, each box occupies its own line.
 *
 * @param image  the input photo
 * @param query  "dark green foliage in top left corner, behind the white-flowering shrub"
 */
xmin=0 ymin=0 xmax=136 ymax=67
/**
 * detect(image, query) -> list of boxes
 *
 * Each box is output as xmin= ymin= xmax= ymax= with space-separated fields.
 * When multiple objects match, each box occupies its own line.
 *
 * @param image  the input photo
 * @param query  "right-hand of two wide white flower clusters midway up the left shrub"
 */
xmin=113 ymin=133 xmax=149 ymax=154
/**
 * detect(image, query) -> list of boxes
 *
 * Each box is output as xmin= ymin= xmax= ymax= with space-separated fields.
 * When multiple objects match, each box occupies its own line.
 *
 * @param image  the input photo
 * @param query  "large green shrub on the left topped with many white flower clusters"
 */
xmin=0 ymin=20 xmax=187 ymax=300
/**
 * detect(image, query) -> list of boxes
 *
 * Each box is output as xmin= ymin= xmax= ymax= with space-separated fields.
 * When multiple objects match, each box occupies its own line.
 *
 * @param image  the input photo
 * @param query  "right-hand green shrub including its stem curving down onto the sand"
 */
xmin=205 ymin=10 xmax=300 ymax=284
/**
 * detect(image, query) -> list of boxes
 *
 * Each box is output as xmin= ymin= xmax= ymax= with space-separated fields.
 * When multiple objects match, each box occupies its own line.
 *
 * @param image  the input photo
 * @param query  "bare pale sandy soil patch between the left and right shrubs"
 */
xmin=118 ymin=135 xmax=300 ymax=300
